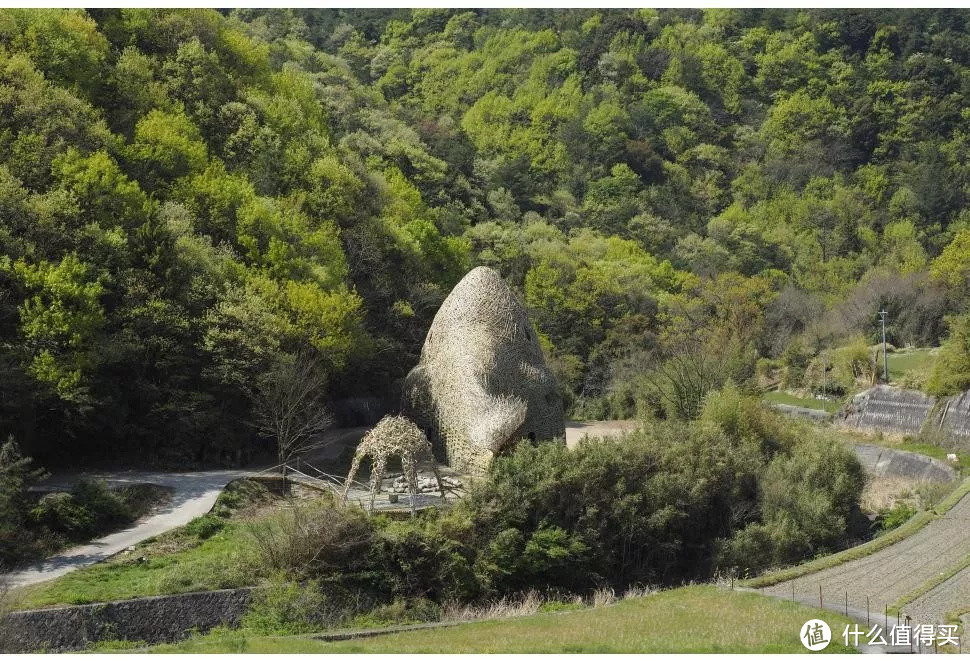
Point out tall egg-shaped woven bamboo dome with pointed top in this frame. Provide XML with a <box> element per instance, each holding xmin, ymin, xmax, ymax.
<box><xmin>403</xmin><ymin>267</ymin><xmax>565</xmax><ymax>473</ymax></box>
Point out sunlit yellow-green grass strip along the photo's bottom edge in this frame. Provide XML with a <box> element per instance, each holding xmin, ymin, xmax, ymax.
<box><xmin>144</xmin><ymin>585</ymin><xmax>854</xmax><ymax>653</ymax></box>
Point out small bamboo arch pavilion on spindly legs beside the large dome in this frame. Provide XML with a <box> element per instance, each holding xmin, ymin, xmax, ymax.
<box><xmin>341</xmin><ymin>416</ymin><xmax>445</xmax><ymax>517</ymax></box>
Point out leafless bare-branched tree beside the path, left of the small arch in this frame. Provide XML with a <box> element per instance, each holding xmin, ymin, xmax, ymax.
<box><xmin>255</xmin><ymin>353</ymin><xmax>333</xmax><ymax>482</ymax></box>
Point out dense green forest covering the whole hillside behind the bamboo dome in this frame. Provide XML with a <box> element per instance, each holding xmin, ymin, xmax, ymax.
<box><xmin>0</xmin><ymin>9</ymin><xmax>970</xmax><ymax>465</ymax></box>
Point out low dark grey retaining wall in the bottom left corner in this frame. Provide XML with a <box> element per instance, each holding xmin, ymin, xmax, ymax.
<box><xmin>0</xmin><ymin>588</ymin><xmax>252</xmax><ymax>653</ymax></box>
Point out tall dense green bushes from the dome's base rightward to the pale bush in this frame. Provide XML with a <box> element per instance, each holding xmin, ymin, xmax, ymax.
<box><xmin>465</xmin><ymin>387</ymin><xmax>865</xmax><ymax>592</ymax></box>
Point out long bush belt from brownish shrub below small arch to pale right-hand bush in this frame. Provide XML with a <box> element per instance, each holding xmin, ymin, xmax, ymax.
<box><xmin>246</xmin><ymin>384</ymin><xmax>868</xmax><ymax>604</ymax></box>
